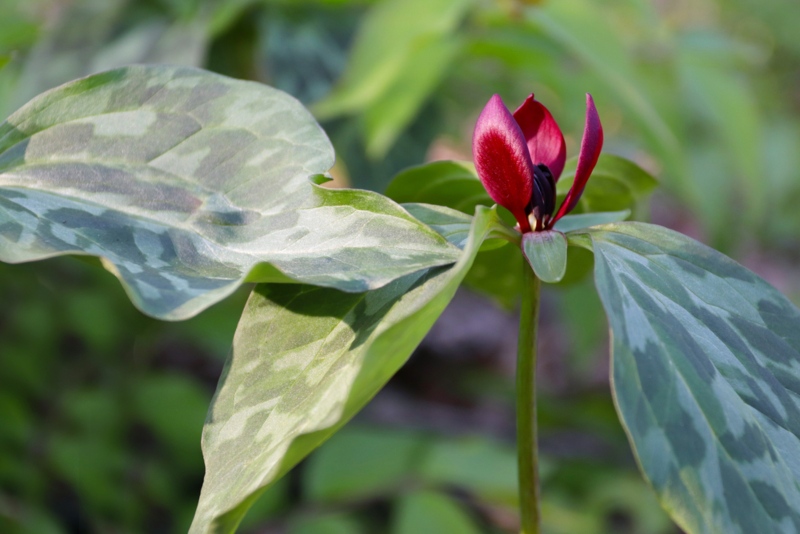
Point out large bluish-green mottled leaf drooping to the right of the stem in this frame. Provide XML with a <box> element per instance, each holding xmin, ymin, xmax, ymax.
<box><xmin>588</xmin><ymin>223</ymin><xmax>800</xmax><ymax>534</ymax></box>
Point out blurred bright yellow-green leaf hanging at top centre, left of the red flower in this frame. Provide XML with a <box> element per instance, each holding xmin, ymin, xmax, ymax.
<box><xmin>313</xmin><ymin>0</ymin><xmax>472</xmax><ymax>160</ymax></box>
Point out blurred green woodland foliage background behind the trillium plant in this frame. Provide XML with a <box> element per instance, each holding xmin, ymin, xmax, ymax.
<box><xmin>0</xmin><ymin>0</ymin><xmax>800</xmax><ymax>534</ymax></box>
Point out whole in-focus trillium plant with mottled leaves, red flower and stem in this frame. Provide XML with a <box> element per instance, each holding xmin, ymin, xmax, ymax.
<box><xmin>0</xmin><ymin>66</ymin><xmax>800</xmax><ymax>534</ymax></box>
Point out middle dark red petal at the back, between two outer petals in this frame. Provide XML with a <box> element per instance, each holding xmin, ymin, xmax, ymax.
<box><xmin>514</xmin><ymin>93</ymin><xmax>567</xmax><ymax>181</ymax></box>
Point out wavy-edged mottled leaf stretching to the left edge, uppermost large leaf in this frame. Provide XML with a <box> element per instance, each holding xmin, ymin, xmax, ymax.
<box><xmin>0</xmin><ymin>66</ymin><xmax>458</xmax><ymax>319</ymax></box>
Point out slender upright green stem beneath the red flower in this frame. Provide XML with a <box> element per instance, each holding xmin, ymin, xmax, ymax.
<box><xmin>516</xmin><ymin>259</ymin><xmax>541</xmax><ymax>534</ymax></box>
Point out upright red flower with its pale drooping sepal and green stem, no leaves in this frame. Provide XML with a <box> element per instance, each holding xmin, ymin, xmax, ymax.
<box><xmin>473</xmin><ymin>94</ymin><xmax>603</xmax><ymax>533</ymax></box>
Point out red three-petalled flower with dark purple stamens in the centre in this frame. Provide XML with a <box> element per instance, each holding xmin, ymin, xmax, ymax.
<box><xmin>472</xmin><ymin>94</ymin><xmax>603</xmax><ymax>234</ymax></box>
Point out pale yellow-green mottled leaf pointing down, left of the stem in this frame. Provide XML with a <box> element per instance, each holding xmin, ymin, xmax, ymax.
<box><xmin>191</xmin><ymin>208</ymin><xmax>497</xmax><ymax>534</ymax></box>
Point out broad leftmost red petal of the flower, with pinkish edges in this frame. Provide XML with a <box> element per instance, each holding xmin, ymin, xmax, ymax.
<box><xmin>472</xmin><ymin>95</ymin><xmax>533</xmax><ymax>233</ymax></box>
